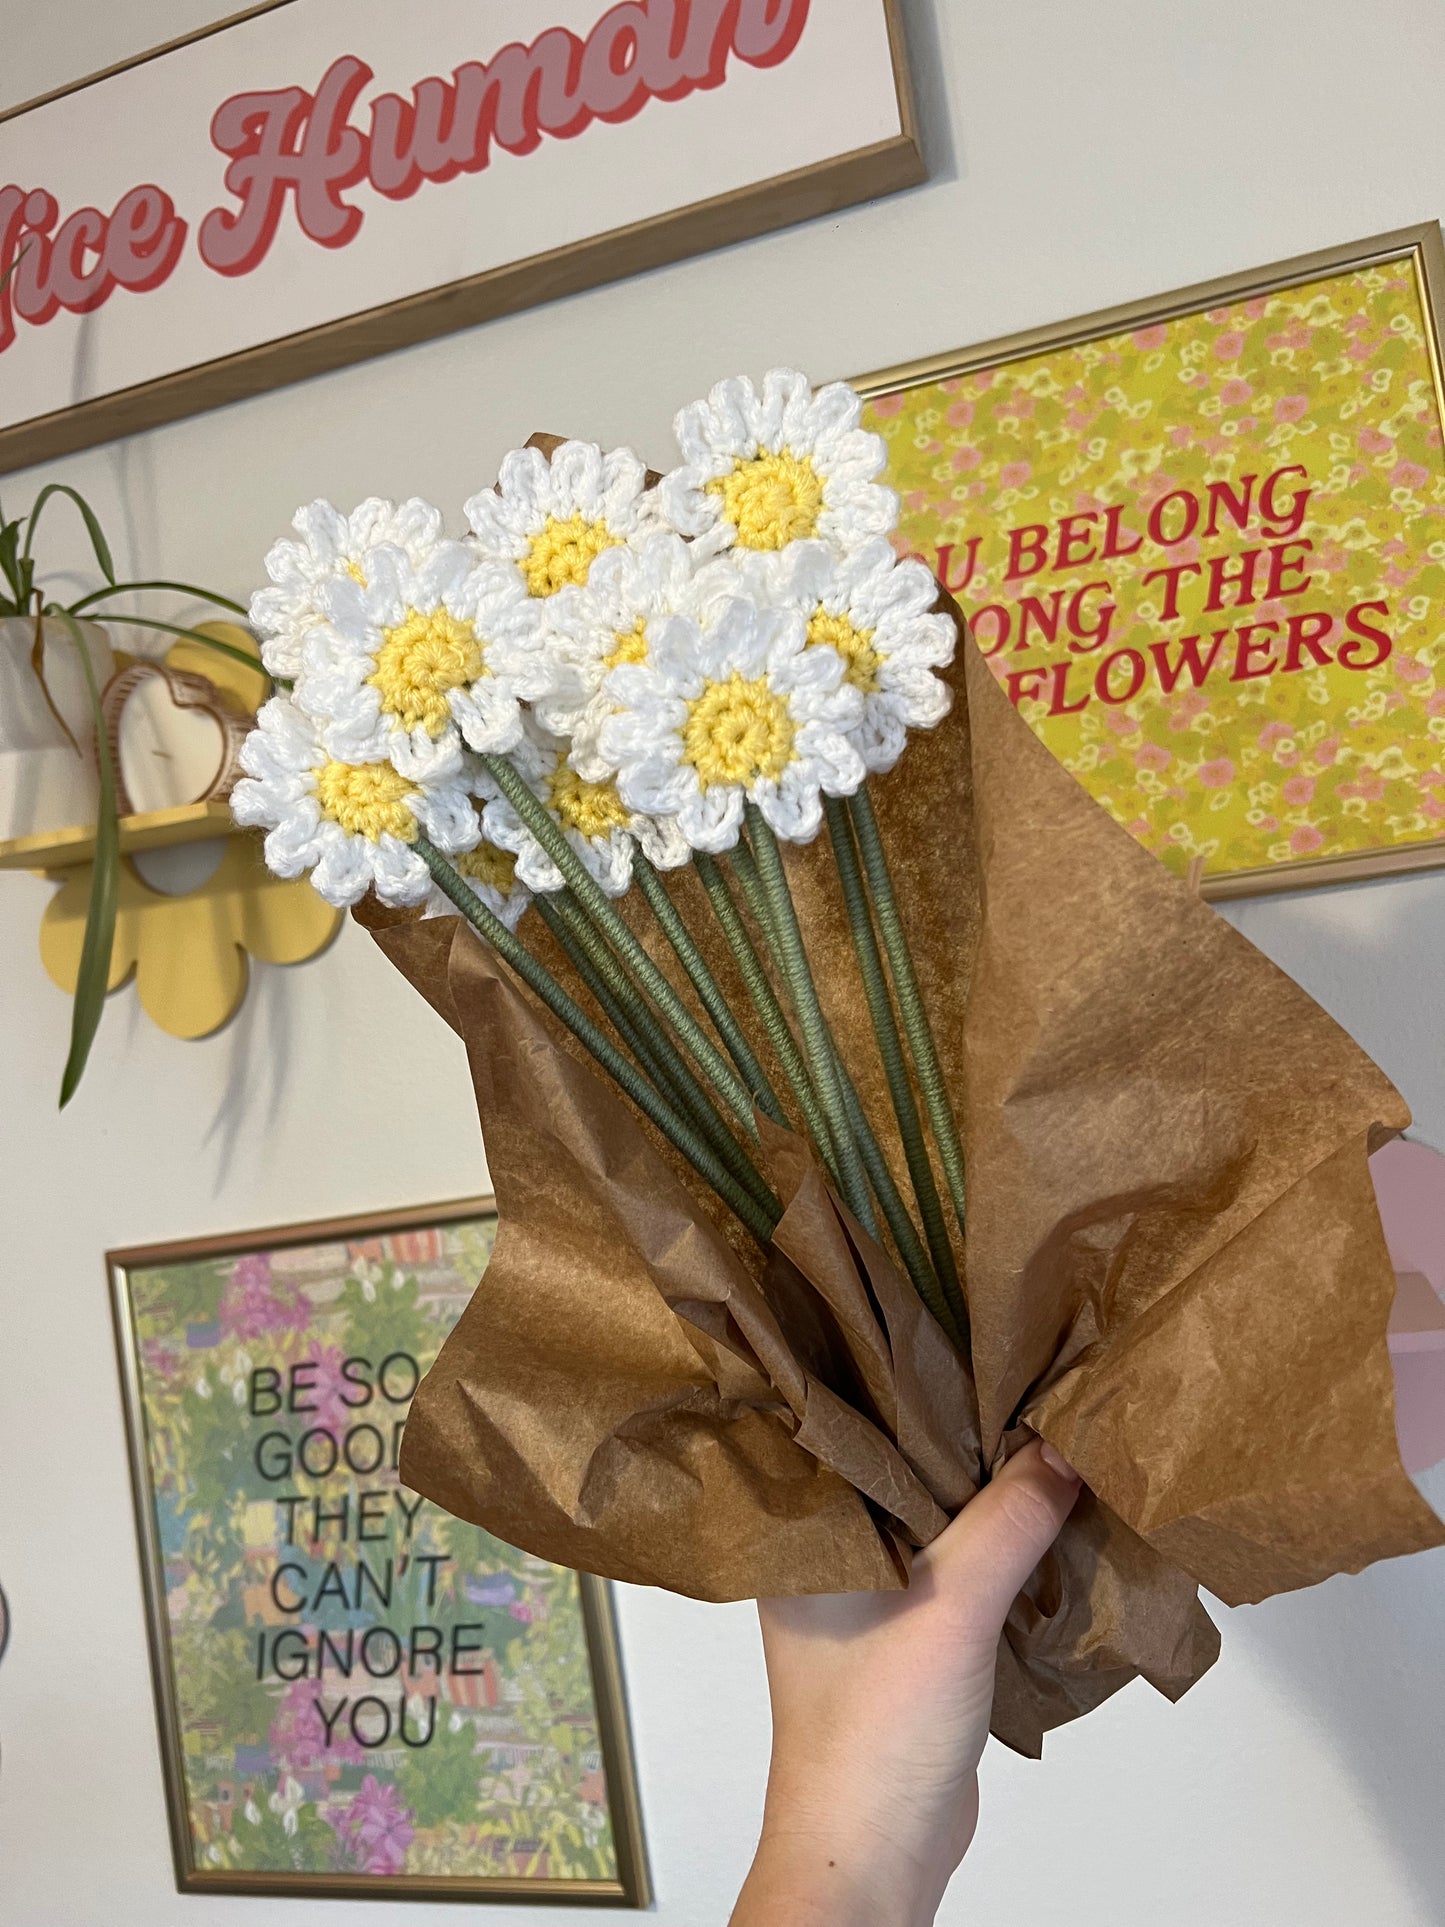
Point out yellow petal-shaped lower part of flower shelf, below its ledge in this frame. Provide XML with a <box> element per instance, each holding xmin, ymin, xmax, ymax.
<box><xmin>40</xmin><ymin>836</ymin><xmax>341</xmax><ymax>1037</ymax></box>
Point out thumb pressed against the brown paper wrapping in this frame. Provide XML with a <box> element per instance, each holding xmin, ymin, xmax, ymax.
<box><xmin>931</xmin><ymin>1439</ymin><xmax>1081</xmax><ymax>1626</ymax></box>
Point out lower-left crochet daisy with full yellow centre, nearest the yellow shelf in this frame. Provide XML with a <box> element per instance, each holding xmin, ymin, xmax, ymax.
<box><xmin>231</xmin><ymin>696</ymin><xmax>480</xmax><ymax>906</ymax></box>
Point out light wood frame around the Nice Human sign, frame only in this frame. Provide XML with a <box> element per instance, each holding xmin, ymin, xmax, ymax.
<box><xmin>0</xmin><ymin>0</ymin><xmax>927</xmax><ymax>474</ymax></box>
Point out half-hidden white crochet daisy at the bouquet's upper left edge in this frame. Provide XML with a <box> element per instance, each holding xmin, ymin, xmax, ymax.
<box><xmin>250</xmin><ymin>495</ymin><xmax>441</xmax><ymax>682</ymax></box>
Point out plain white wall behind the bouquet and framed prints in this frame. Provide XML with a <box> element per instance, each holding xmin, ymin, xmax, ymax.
<box><xmin>0</xmin><ymin>0</ymin><xmax>1445</xmax><ymax>1927</ymax></box>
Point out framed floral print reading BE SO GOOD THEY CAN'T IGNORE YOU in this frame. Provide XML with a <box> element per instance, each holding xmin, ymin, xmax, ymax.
<box><xmin>108</xmin><ymin>1199</ymin><xmax>649</xmax><ymax>1908</ymax></box>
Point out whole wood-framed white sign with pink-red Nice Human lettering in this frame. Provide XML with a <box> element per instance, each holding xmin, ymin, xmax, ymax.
<box><xmin>0</xmin><ymin>0</ymin><xmax>925</xmax><ymax>468</ymax></box>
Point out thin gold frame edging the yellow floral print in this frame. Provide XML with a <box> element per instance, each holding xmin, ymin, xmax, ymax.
<box><xmin>852</xmin><ymin>222</ymin><xmax>1445</xmax><ymax>900</ymax></box>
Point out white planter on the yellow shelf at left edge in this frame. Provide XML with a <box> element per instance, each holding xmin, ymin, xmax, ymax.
<box><xmin>0</xmin><ymin>617</ymin><xmax>116</xmax><ymax>842</ymax></box>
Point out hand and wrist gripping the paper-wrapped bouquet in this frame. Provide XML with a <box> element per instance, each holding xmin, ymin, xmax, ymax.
<box><xmin>732</xmin><ymin>1443</ymin><xmax>1079</xmax><ymax>1927</ymax></box>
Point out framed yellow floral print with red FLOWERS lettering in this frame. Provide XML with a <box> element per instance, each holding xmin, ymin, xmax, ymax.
<box><xmin>855</xmin><ymin>222</ymin><xmax>1445</xmax><ymax>896</ymax></box>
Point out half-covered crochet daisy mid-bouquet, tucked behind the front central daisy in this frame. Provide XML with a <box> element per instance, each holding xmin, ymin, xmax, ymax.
<box><xmin>536</xmin><ymin>534</ymin><xmax>738</xmax><ymax>782</ymax></box>
